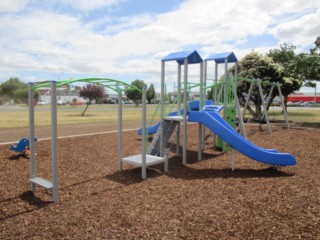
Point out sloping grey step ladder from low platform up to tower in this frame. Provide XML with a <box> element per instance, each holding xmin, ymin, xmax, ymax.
<box><xmin>147</xmin><ymin>119</ymin><xmax>180</xmax><ymax>156</ymax></box>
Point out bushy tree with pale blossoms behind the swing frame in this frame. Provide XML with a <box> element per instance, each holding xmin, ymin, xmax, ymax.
<box><xmin>237</xmin><ymin>52</ymin><xmax>283</xmax><ymax>120</ymax></box>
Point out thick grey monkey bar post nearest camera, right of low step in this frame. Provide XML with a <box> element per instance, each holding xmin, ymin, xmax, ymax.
<box><xmin>51</xmin><ymin>81</ymin><xmax>59</xmax><ymax>203</ymax></box>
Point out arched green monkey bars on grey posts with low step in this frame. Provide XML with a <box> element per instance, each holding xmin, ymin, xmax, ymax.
<box><xmin>29</xmin><ymin>78</ymin><xmax>141</xmax><ymax>203</ymax></box>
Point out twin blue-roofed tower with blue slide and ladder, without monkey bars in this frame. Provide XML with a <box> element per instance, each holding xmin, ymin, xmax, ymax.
<box><xmin>145</xmin><ymin>51</ymin><xmax>296</xmax><ymax>169</ymax></box>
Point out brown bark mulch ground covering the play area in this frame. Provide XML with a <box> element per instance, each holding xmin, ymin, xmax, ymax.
<box><xmin>0</xmin><ymin>124</ymin><xmax>320</xmax><ymax>239</ymax></box>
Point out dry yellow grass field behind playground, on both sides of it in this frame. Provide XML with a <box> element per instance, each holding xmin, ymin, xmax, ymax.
<box><xmin>0</xmin><ymin>104</ymin><xmax>320</xmax><ymax>129</ymax></box>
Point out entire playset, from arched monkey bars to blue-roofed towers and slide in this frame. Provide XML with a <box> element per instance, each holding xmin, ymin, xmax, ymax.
<box><xmin>25</xmin><ymin>51</ymin><xmax>296</xmax><ymax>203</ymax></box>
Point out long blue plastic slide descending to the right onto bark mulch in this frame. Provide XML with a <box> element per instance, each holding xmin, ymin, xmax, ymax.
<box><xmin>188</xmin><ymin>111</ymin><xmax>297</xmax><ymax>166</ymax></box>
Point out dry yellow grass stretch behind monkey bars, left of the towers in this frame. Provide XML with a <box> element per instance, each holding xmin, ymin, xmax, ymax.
<box><xmin>0</xmin><ymin>105</ymin><xmax>160</xmax><ymax>129</ymax></box>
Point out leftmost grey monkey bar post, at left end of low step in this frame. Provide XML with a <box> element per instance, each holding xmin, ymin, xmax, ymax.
<box><xmin>28</xmin><ymin>83</ymin><xmax>36</xmax><ymax>192</ymax></box>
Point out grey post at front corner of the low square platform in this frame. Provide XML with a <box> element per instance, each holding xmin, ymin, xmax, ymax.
<box><xmin>141</xmin><ymin>86</ymin><xmax>147</xmax><ymax>179</ymax></box>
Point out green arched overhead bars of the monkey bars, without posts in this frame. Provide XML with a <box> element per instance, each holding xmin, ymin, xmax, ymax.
<box><xmin>32</xmin><ymin>78</ymin><xmax>142</xmax><ymax>93</ymax></box>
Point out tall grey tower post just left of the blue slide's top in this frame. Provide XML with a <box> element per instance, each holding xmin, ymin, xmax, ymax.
<box><xmin>182</xmin><ymin>58</ymin><xmax>188</xmax><ymax>164</ymax></box>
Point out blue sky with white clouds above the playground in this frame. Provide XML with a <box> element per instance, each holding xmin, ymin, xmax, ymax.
<box><xmin>0</xmin><ymin>0</ymin><xmax>320</xmax><ymax>92</ymax></box>
